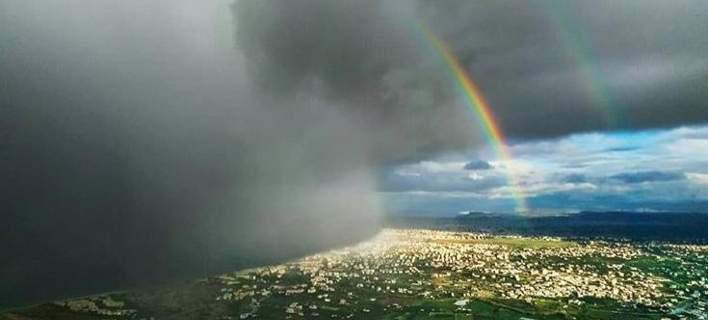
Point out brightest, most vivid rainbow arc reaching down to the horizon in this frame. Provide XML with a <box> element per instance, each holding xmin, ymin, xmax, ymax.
<box><xmin>422</xmin><ymin>26</ymin><xmax>528</xmax><ymax>212</ymax></box>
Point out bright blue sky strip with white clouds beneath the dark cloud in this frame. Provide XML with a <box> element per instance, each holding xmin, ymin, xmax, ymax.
<box><xmin>380</xmin><ymin>126</ymin><xmax>708</xmax><ymax>216</ymax></box>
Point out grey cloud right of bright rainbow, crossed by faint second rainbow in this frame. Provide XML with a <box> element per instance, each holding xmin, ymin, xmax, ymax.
<box><xmin>424</xmin><ymin>1</ymin><xmax>708</xmax><ymax>139</ymax></box>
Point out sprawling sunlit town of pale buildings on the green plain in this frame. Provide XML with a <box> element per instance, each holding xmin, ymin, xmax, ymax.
<box><xmin>212</xmin><ymin>229</ymin><xmax>708</xmax><ymax>318</ymax></box>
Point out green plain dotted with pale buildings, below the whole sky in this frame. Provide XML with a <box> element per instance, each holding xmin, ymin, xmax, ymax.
<box><xmin>5</xmin><ymin>229</ymin><xmax>708</xmax><ymax>319</ymax></box>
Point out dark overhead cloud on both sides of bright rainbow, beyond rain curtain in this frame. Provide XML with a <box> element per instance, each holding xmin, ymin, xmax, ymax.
<box><xmin>234</xmin><ymin>0</ymin><xmax>708</xmax><ymax>142</ymax></box>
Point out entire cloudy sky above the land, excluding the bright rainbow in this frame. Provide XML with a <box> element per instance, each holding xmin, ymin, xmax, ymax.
<box><xmin>0</xmin><ymin>0</ymin><xmax>708</xmax><ymax>304</ymax></box>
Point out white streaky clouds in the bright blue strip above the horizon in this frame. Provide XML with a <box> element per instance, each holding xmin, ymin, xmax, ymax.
<box><xmin>382</xmin><ymin>126</ymin><xmax>708</xmax><ymax>215</ymax></box>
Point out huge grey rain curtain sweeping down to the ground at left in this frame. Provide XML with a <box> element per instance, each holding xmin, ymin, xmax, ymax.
<box><xmin>0</xmin><ymin>0</ymin><xmax>392</xmax><ymax>308</ymax></box>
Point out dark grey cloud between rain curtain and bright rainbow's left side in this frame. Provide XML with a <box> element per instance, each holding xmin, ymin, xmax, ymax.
<box><xmin>233</xmin><ymin>0</ymin><xmax>479</xmax><ymax>162</ymax></box>
